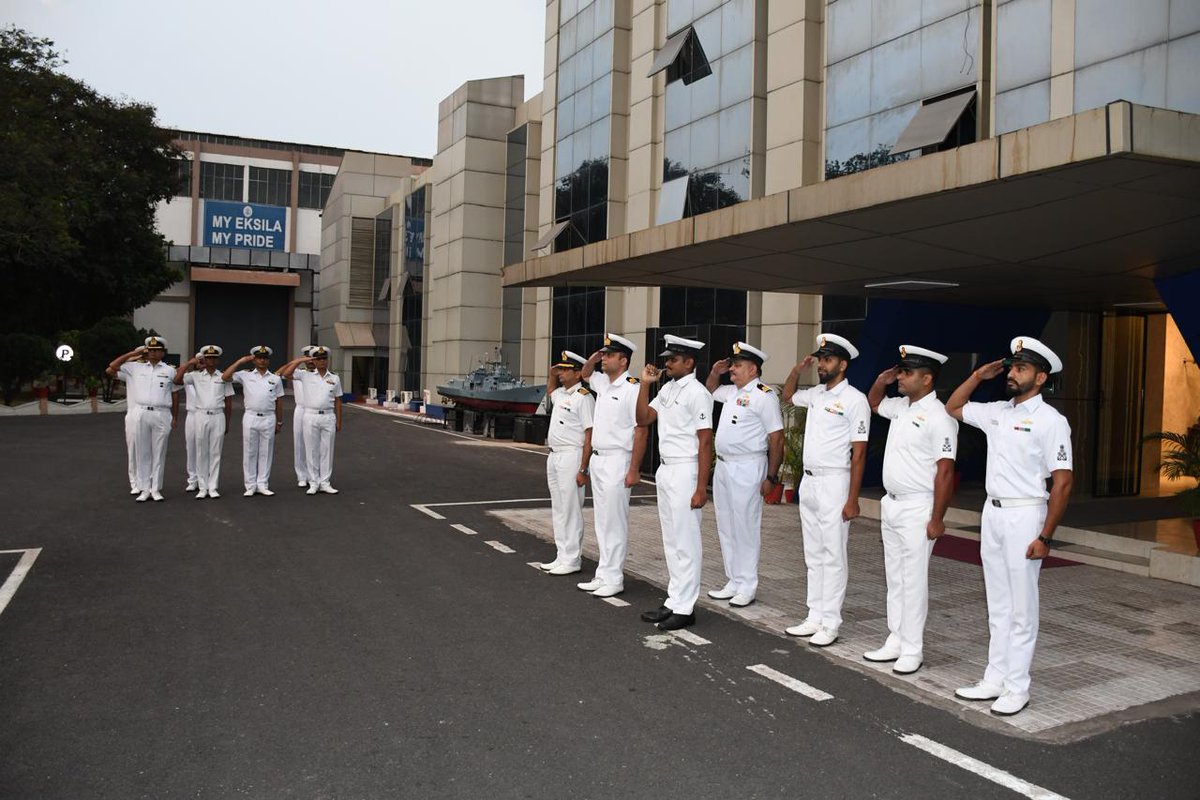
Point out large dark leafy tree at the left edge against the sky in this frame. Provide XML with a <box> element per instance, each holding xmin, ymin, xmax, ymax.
<box><xmin>0</xmin><ymin>28</ymin><xmax>181</xmax><ymax>336</ymax></box>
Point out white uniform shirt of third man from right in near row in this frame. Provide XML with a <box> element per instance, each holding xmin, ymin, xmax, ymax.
<box><xmin>792</xmin><ymin>379</ymin><xmax>871</xmax><ymax>469</ymax></box>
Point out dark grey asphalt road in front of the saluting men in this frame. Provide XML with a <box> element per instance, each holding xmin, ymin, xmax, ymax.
<box><xmin>0</xmin><ymin>410</ymin><xmax>1200</xmax><ymax>800</ymax></box>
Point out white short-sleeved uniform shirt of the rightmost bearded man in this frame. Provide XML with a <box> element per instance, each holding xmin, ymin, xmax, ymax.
<box><xmin>962</xmin><ymin>395</ymin><xmax>1072</xmax><ymax>499</ymax></box>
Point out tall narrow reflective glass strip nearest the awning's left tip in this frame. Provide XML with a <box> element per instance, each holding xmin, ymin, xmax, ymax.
<box><xmin>554</xmin><ymin>0</ymin><xmax>614</xmax><ymax>251</ymax></box>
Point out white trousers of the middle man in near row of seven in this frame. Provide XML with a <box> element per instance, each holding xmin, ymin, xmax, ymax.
<box><xmin>713</xmin><ymin>455</ymin><xmax>767</xmax><ymax>597</ymax></box>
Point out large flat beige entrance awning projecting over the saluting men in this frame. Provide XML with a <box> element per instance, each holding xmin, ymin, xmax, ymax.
<box><xmin>504</xmin><ymin>102</ymin><xmax>1200</xmax><ymax>309</ymax></box>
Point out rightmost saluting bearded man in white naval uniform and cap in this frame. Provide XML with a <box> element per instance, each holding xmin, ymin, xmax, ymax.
<box><xmin>946</xmin><ymin>336</ymin><xmax>1073</xmax><ymax>716</ymax></box>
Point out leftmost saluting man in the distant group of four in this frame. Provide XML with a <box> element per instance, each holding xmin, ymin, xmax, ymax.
<box><xmin>106</xmin><ymin>336</ymin><xmax>179</xmax><ymax>503</ymax></box>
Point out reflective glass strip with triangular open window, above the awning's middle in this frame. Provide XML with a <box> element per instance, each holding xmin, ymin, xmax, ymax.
<box><xmin>662</xmin><ymin>0</ymin><xmax>755</xmax><ymax>215</ymax></box>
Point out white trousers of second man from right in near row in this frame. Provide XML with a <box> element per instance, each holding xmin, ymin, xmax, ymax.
<box><xmin>880</xmin><ymin>494</ymin><xmax>934</xmax><ymax>661</ymax></box>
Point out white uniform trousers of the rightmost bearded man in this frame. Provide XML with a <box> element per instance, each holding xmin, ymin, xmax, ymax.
<box><xmin>979</xmin><ymin>503</ymin><xmax>1046</xmax><ymax>694</ymax></box>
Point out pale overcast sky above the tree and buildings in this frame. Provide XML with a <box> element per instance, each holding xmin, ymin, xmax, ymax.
<box><xmin>7</xmin><ymin>0</ymin><xmax>546</xmax><ymax>156</ymax></box>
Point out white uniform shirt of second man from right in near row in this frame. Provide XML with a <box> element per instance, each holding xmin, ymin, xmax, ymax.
<box><xmin>876</xmin><ymin>392</ymin><xmax>959</xmax><ymax>494</ymax></box>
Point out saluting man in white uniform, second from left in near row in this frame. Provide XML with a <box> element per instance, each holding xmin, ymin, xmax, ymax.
<box><xmin>576</xmin><ymin>333</ymin><xmax>648</xmax><ymax>597</ymax></box>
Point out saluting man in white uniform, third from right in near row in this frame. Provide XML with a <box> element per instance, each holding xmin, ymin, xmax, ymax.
<box><xmin>784</xmin><ymin>333</ymin><xmax>871</xmax><ymax>648</ymax></box>
